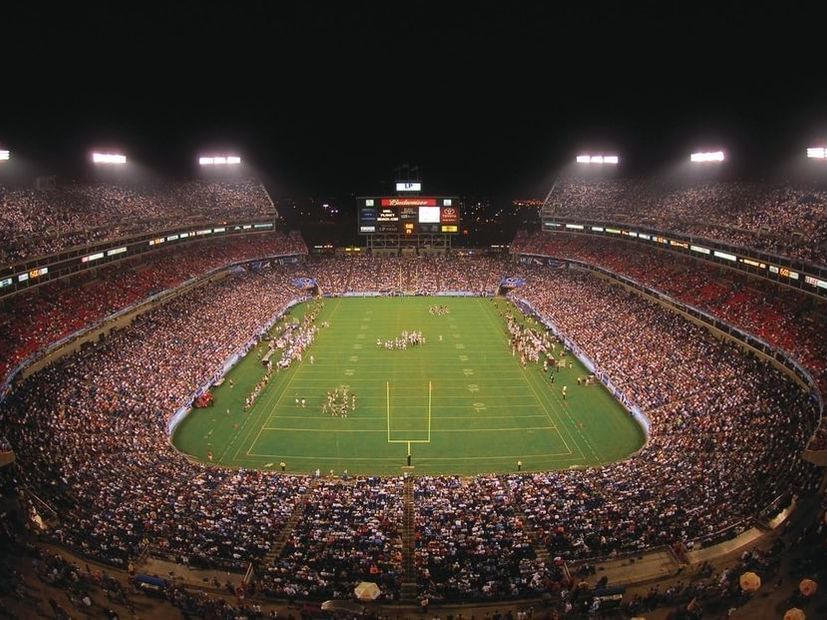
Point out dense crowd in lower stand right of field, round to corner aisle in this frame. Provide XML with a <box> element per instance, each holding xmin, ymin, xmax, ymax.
<box><xmin>509</xmin><ymin>269</ymin><xmax>818</xmax><ymax>558</ymax></box>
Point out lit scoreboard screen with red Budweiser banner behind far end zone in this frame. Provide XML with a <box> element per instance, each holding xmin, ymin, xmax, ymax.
<box><xmin>357</xmin><ymin>196</ymin><xmax>459</xmax><ymax>235</ymax></box>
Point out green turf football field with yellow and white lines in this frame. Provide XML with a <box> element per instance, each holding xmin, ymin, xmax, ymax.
<box><xmin>174</xmin><ymin>297</ymin><xmax>644</xmax><ymax>475</ymax></box>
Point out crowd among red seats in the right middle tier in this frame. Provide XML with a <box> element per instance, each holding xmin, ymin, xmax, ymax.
<box><xmin>512</xmin><ymin>233</ymin><xmax>827</xmax><ymax>449</ymax></box>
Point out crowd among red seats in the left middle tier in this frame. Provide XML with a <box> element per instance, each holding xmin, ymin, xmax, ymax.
<box><xmin>0</xmin><ymin>233</ymin><xmax>307</xmax><ymax>382</ymax></box>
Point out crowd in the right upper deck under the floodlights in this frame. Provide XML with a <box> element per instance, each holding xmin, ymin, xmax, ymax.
<box><xmin>549</xmin><ymin>177</ymin><xmax>827</xmax><ymax>265</ymax></box>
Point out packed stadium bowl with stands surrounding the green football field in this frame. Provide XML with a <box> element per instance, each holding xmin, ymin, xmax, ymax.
<box><xmin>2</xmin><ymin>159</ymin><xmax>827</xmax><ymax>616</ymax></box>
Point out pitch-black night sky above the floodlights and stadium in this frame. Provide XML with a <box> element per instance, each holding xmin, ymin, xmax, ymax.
<box><xmin>0</xmin><ymin>0</ymin><xmax>827</xmax><ymax>196</ymax></box>
